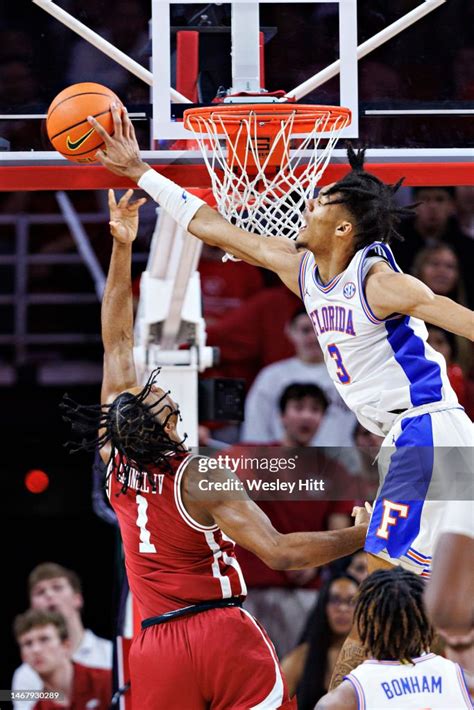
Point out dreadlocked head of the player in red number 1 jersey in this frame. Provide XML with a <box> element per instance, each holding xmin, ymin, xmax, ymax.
<box><xmin>60</xmin><ymin>368</ymin><xmax>186</xmax><ymax>493</ymax></box>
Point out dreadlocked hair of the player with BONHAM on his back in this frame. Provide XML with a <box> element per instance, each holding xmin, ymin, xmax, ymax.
<box><xmin>354</xmin><ymin>567</ymin><xmax>433</xmax><ymax>663</ymax></box>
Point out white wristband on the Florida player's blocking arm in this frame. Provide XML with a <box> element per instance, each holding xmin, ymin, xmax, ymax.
<box><xmin>138</xmin><ymin>169</ymin><xmax>206</xmax><ymax>229</ymax></box>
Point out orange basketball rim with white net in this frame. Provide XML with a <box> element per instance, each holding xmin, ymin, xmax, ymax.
<box><xmin>184</xmin><ymin>103</ymin><xmax>351</xmax><ymax>245</ymax></box>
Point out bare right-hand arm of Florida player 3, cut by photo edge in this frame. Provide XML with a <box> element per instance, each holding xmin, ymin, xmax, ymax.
<box><xmin>365</xmin><ymin>262</ymin><xmax>474</xmax><ymax>340</ymax></box>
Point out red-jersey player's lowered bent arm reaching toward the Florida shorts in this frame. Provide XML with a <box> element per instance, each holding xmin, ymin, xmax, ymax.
<box><xmin>184</xmin><ymin>459</ymin><xmax>369</xmax><ymax>570</ymax></box>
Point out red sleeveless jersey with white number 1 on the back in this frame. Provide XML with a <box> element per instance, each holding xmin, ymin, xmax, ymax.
<box><xmin>108</xmin><ymin>451</ymin><xmax>247</xmax><ymax>619</ymax></box>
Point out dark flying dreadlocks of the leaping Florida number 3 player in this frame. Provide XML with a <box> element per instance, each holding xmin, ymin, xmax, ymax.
<box><xmin>324</xmin><ymin>145</ymin><xmax>416</xmax><ymax>250</ymax></box>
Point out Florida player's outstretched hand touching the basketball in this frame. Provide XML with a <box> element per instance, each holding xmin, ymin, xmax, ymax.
<box><xmin>87</xmin><ymin>103</ymin><xmax>150</xmax><ymax>182</ymax></box>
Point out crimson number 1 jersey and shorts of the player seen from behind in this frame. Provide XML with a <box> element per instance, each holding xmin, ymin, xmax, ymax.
<box><xmin>108</xmin><ymin>452</ymin><xmax>292</xmax><ymax>710</ymax></box>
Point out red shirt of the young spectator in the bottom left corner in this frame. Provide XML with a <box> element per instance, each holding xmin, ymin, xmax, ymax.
<box><xmin>33</xmin><ymin>663</ymin><xmax>112</xmax><ymax>710</ymax></box>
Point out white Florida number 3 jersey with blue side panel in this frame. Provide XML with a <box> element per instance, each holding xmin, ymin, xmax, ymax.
<box><xmin>299</xmin><ymin>242</ymin><xmax>458</xmax><ymax>436</ymax></box>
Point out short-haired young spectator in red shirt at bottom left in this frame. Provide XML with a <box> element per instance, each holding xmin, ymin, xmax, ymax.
<box><xmin>14</xmin><ymin>609</ymin><xmax>112</xmax><ymax>710</ymax></box>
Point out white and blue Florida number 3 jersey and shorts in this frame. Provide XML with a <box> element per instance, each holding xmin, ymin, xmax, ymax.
<box><xmin>299</xmin><ymin>242</ymin><xmax>473</xmax><ymax>576</ymax></box>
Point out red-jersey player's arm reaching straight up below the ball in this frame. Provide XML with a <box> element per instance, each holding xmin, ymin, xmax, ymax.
<box><xmin>101</xmin><ymin>190</ymin><xmax>146</xmax><ymax>403</ymax></box>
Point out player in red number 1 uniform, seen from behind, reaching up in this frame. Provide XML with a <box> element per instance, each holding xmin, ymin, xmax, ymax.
<box><xmin>61</xmin><ymin>190</ymin><xmax>368</xmax><ymax>710</ymax></box>
